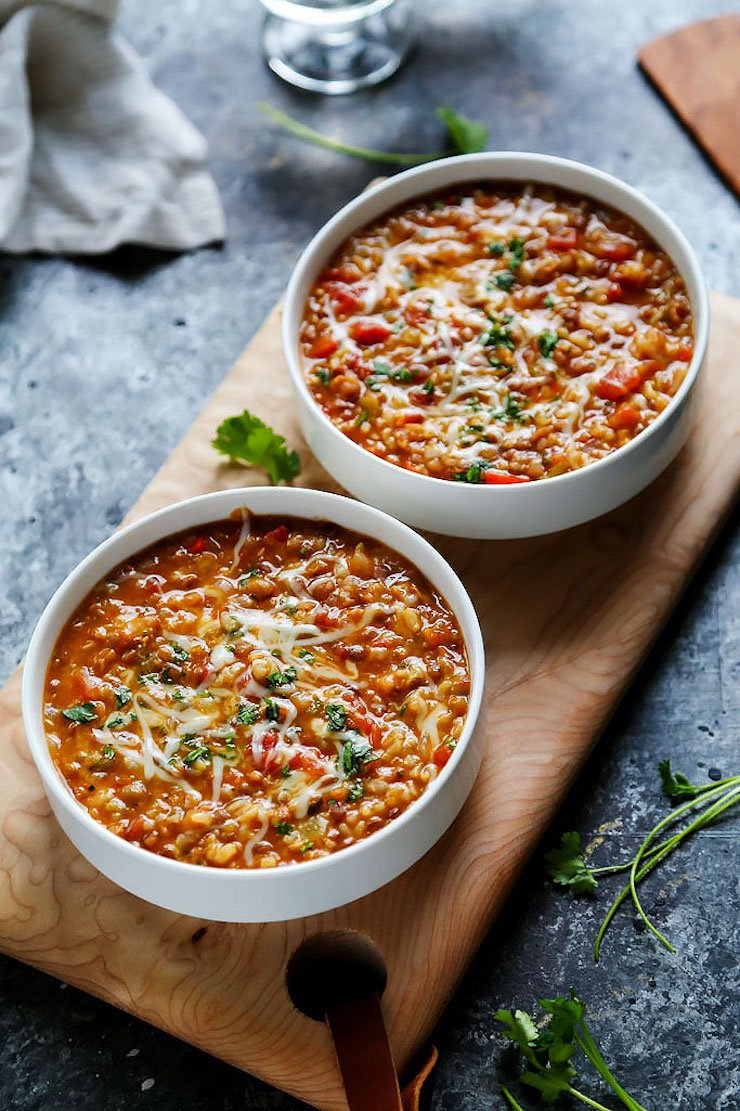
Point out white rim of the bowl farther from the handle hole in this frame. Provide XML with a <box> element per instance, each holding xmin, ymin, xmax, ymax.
<box><xmin>281</xmin><ymin>151</ymin><xmax>710</xmax><ymax>498</ymax></box>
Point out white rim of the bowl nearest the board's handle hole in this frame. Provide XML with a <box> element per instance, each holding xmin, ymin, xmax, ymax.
<box><xmin>21</xmin><ymin>487</ymin><xmax>486</xmax><ymax>888</ymax></box>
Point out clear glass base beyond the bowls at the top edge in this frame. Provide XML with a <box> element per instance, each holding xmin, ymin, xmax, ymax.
<box><xmin>260</xmin><ymin>0</ymin><xmax>416</xmax><ymax>94</ymax></box>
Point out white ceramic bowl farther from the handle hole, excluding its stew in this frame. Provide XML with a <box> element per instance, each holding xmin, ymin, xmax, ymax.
<box><xmin>282</xmin><ymin>152</ymin><xmax>709</xmax><ymax>539</ymax></box>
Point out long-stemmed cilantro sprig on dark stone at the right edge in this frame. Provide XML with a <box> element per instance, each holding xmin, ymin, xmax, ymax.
<box><xmin>544</xmin><ymin>760</ymin><xmax>740</xmax><ymax>961</ymax></box>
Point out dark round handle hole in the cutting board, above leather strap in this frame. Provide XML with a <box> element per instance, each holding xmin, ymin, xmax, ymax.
<box><xmin>286</xmin><ymin>930</ymin><xmax>388</xmax><ymax>1022</ymax></box>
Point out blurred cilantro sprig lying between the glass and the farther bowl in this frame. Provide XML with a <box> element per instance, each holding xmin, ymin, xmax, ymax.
<box><xmin>257</xmin><ymin>101</ymin><xmax>488</xmax><ymax>166</ymax></box>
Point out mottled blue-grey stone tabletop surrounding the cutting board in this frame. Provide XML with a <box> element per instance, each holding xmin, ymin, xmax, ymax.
<box><xmin>0</xmin><ymin>0</ymin><xmax>740</xmax><ymax>1111</ymax></box>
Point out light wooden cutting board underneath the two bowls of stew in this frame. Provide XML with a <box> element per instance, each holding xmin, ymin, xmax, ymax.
<box><xmin>0</xmin><ymin>296</ymin><xmax>740</xmax><ymax>1111</ymax></box>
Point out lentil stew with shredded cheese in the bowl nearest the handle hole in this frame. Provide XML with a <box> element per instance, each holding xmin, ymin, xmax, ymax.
<box><xmin>44</xmin><ymin>512</ymin><xmax>470</xmax><ymax>869</ymax></box>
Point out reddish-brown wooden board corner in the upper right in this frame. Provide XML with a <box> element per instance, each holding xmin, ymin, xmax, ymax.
<box><xmin>638</xmin><ymin>12</ymin><xmax>740</xmax><ymax>196</ymax></box>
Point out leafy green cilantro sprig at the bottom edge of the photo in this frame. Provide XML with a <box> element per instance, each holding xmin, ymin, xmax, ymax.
<box><xmin>494</xmin><ymin>992</ymin><xmax>646</xmax><ymax>1111</ymax></box>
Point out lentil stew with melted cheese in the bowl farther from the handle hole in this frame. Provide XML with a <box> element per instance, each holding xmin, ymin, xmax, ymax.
<box><xmin>300</xmin><ymin>184</ymin><xmax>692</xmax><ymax>484</ymax></box>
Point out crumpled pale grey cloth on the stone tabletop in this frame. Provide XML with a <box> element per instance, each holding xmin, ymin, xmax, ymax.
<box><xmin>0</xmin><ymin>0</ymin><xmax>224</xmax><ymax>254</ymax></box>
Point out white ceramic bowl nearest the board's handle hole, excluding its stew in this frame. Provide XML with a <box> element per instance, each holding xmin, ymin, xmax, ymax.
<box><xmin>22</xmin><ymin>488</ymin><xmax>484</xmax><ymax>922</ymax></box>
